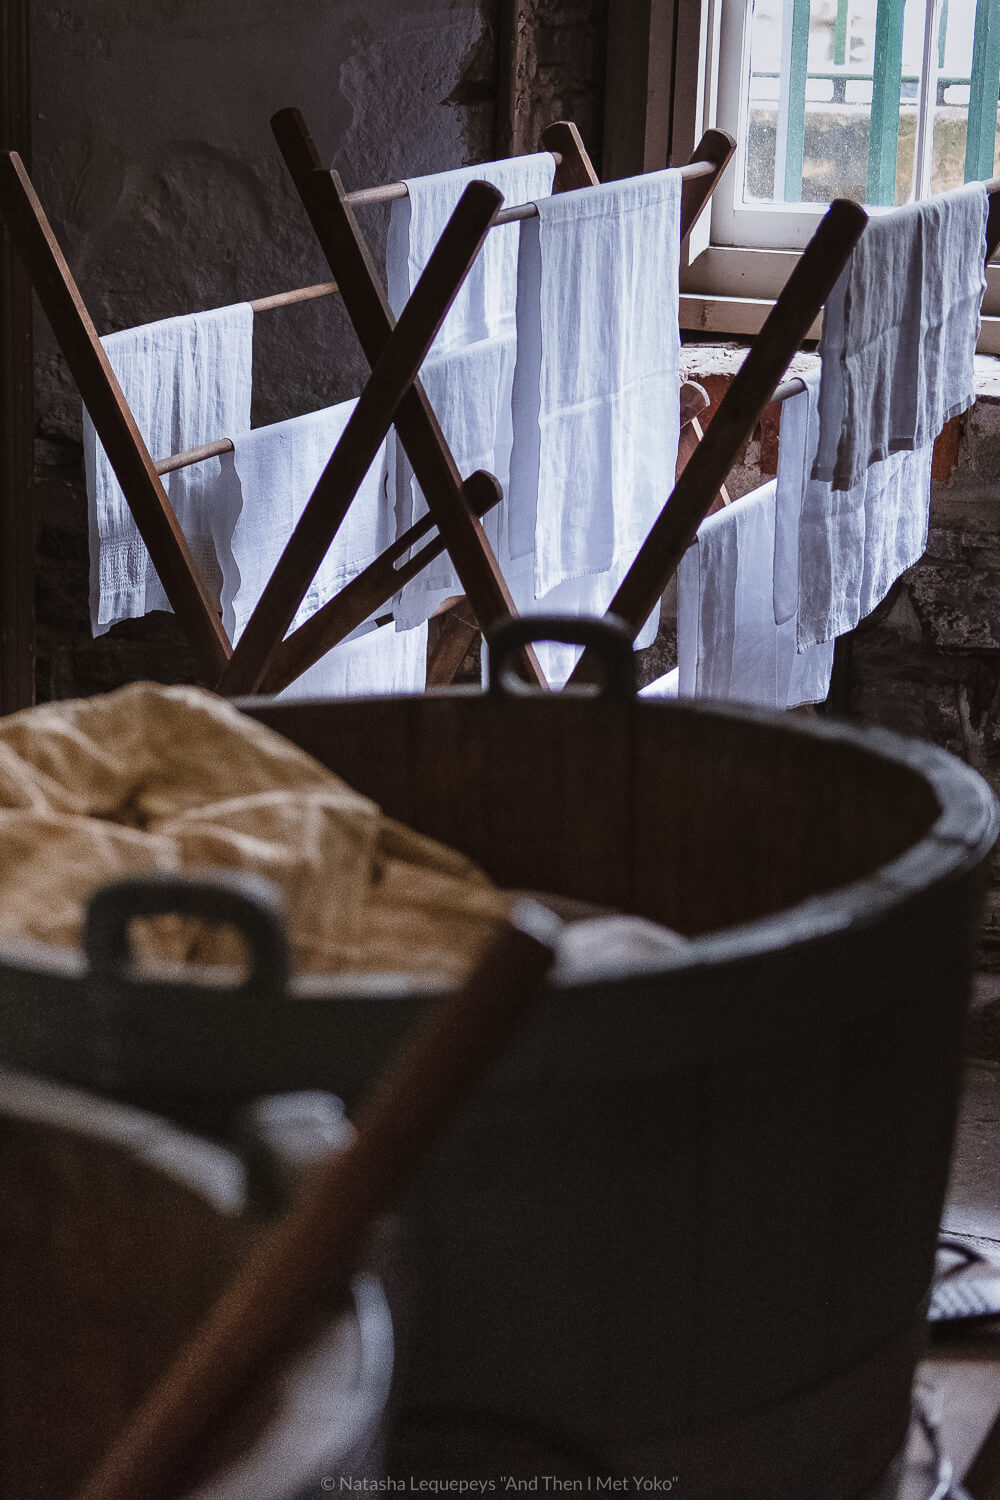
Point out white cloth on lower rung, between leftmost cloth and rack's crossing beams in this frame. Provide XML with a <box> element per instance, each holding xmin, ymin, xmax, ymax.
<box><xmin>223</xmin><ymin>401</ymin><xmax>427</xmax><ymax>698</ymax></box>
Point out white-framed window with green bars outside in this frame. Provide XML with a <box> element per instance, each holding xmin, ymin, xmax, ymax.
<box><xmin>685</xmin><ymin>0</ymin><xmax>1000</xmax><ymax>350</ymax></box>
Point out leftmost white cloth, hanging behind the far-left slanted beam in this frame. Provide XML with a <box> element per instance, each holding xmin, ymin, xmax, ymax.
<box><xmin>84</xmin><ymin>303</ymin><xmax>253</xmax><ymax>636</ymax></box>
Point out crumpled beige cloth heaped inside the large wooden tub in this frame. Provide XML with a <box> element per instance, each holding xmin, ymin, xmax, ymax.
<box><xmin>0</xmin><ymin>683</ymin><xmax>510</xmax><ymax>978</ymax></box>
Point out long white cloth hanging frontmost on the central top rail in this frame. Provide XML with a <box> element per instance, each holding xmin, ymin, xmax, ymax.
<box><xmin>508</xmin><ymin>171</ymin><xmax>681</xmax><ymax>686</ymax></box>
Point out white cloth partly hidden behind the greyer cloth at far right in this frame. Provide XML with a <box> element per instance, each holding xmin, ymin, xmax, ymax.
<box><xmin>774</xmin><ymin>370</ymin><xmax>934</xmax><ymax>651</ymax></box>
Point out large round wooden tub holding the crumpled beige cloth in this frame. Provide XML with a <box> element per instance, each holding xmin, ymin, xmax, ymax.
<box><xmin>0</xmin><ymin>618</ymin><xmax>997</xmax><ymax>1500</ymax></box>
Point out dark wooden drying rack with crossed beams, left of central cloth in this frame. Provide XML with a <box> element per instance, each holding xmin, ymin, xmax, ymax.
<box><xmin>0</xmin><ymin>120</ymin><xmax>733</xmax><ymax>695</ymax></box>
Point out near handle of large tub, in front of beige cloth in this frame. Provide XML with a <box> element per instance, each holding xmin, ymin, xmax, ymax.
<box><xmin>82</xmin><ymin>870</ymin><xmax>289</xmax><ymax>996</ymax></box>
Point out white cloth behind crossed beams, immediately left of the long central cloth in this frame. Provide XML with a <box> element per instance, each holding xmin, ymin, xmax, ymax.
<box><xmin>385</xmin><ymin>152</ymin><xmax>555</xmax><ymax>629</ymax></box>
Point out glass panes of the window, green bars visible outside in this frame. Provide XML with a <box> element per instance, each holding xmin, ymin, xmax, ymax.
<box><xmin>742</xmin><ymin>0</ymin><xmax>1000</xmax><ymax>206</ymax></box>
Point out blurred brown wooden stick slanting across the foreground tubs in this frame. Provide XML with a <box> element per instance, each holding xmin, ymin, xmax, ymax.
<box><xmin>78</xmin><ymin>902</ymin><xmax>558</xmax><ymax>1500</ymax></box>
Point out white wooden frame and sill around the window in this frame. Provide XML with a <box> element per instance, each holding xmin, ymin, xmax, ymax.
<box><xmin>673</xmin><ymin>0</ymin><xmax>1000</xmax><ymax>354</ymax></box>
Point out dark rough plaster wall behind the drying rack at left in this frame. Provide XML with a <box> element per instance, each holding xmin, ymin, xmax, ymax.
<box><xmin>31</xmin><ymin>0</ymin><xmax>496</xmax><ymax>698</ymax></box>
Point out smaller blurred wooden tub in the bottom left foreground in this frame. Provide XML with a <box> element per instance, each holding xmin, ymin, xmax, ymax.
<box><xmin>0</xmin><ymin>1070</ymin><xmax>391</xmax><ymax>1500</ymax></box>
